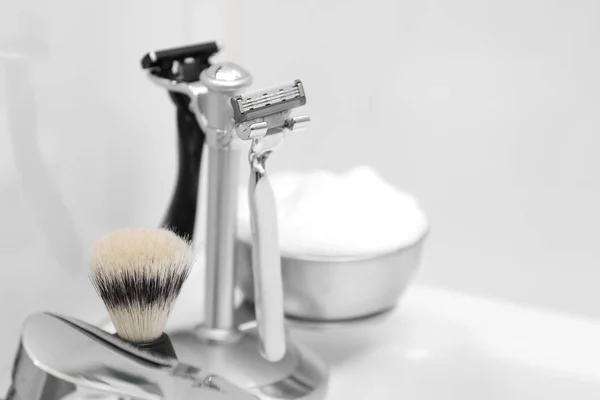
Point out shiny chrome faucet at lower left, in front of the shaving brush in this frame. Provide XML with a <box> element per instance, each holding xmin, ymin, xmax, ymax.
<box><xmin>7</xmin><ymin>313</ymin><xmax>255</xmax><ymax>400</ymax></box>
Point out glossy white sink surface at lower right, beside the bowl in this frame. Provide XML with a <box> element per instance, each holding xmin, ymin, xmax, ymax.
<box><xmin>294</xmin><ymin>286</ymin><xmax>600</xmax><ymax>400</ymax></box>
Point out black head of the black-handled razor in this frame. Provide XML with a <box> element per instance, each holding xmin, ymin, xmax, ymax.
<box><xmin>141</xmin><ymin>42</ymin><xmax>219</xmax><ymax>82</ymax></box>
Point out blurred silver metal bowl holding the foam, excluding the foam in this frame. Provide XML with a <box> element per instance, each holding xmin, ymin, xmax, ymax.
<box><xmin>236</xmin><ymin>235</ymin><xmax>426</xmax><ymax>322</ymax></box>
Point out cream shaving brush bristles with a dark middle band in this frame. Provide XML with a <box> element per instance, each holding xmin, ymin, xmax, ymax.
<box><xmin>90</xmin><ymin>228</ymin><xmax>194</xmax><ymax>343</ymax></box>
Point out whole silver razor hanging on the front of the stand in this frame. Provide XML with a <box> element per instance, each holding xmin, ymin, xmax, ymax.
<box><xmin>231</xmin><ymin>80</ymin><xmax>310</xmax><ymax>362</ymax></box>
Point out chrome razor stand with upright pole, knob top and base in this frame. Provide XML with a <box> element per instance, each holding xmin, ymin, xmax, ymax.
<box><xmin>150</xmin><ymin>63</ymin><xmax>328</xmax><ymax>400</ymax></box>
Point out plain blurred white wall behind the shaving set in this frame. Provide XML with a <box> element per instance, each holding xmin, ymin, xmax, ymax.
<box><xmin>0</xmin><ymin>0</ymin><xmax>600</xmax><ymax>376</ymax></box>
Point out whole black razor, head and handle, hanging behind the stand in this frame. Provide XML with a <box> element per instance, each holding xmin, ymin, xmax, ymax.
<box><xmin>141</xmin><ymin>42</ymin><xmax>219</xmax><ymax>240</ymax></box>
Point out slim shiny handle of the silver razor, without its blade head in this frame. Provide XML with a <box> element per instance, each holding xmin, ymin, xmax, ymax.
<box><xmin>248</xmin><ymin>134</ymin><xmax>286</xmax><ymax>361</ymax></box>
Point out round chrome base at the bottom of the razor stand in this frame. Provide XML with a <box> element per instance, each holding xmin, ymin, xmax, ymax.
<box><xmin>169</xmin><ymin>327</ymin><xmax>328</xmax><ymax>400</ymax></box>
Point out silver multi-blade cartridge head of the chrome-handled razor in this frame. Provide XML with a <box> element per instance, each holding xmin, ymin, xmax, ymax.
<box><xmin>231</xmin><ymin>79</ymin><xmax>306</xmax><ymax>124</ymax></box>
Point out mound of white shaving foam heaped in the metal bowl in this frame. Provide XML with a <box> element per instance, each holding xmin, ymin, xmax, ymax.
<box><xmin>238</xmin><ymin>167</ymin><xmax>428</xmax><ymax>258</ymax></box>
